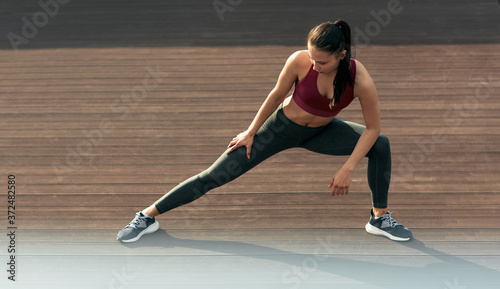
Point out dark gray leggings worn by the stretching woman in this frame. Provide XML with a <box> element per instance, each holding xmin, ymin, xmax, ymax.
<box><xmin>155</xmin><ymin>108</ymin><xmax>391</xmax><ymax>214</ymax></box>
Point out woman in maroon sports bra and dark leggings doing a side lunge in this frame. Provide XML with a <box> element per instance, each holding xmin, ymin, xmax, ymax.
<box><xmin>117</xmin><ymin>20</ymin><xmax>412</xmax><ymax>242</ymax></box>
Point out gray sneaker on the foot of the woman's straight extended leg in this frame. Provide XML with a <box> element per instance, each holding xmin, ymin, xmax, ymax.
<box><xmin>116</xmin><ymin>212</ymin><xmax>160</xmax><ymax>243</ymax></box>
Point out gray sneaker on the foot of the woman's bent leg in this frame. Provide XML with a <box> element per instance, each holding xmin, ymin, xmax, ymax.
<box><xmin>365</xmin><ymin>210</ymin><xmax>413</xmax><ymax>241</ymax></box>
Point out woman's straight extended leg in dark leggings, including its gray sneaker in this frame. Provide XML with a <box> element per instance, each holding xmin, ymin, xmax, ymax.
<box><xmin>117</xmin><ymin>109</ymin><xmax>300</xmax><ymax>242</ymax></box>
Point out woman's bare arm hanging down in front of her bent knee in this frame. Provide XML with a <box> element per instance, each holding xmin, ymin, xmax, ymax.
<box><xmin>329</xmin><ymin>61</ymin><xmax>380</xmax><ymax>196</ymax></box>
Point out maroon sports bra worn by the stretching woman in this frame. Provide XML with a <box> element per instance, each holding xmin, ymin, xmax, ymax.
<box><xmin>292</xmin><ymin>58</ymin><xmax>356</xmax><ymax>117</ymax></box>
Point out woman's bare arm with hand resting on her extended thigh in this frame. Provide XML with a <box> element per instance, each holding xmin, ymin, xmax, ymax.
<box><xmin>227</xmin><ymin>51</ymin><xmax>303</xmax><ymax>158</ymax></box>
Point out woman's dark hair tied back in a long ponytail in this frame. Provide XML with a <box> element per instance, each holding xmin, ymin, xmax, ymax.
<box><xmin>307</xmin><ymin>19</ymin><xmax>354</xmax><ymax>106</ymax></box>
